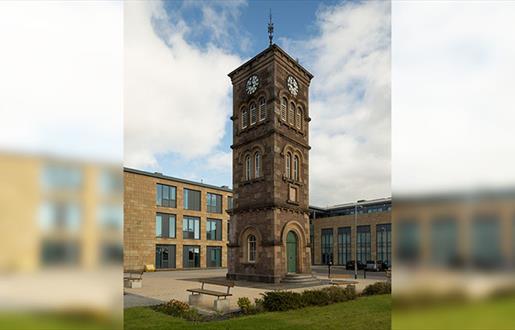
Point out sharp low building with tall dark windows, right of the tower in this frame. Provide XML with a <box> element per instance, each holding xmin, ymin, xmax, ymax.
<box><xmin>310</xmin><ymin>198</ymin><xmax>392</xmax><ymax>266</ymax></box>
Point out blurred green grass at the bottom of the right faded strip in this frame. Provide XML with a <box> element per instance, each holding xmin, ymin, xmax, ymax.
<box><xmin>392</xmin><ymin>297</ymin><xmax>515</xmax><ymax>330</ymax></box>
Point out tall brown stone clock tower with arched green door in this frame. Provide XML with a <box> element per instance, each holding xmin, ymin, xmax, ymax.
<box><xmin>227</xmin><ymin>38</ymin><xmax>313</xmax><ymax>283</ymax></box>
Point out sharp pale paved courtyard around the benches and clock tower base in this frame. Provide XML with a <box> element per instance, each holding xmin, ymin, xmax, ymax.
<box><xmin>124</xmin><ymin>269</ymin><xmax>379</xmax><ymax>310</ymax></box>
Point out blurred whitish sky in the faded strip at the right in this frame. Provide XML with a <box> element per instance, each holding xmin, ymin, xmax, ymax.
<box><xmin>392</xmin><ymin>2</ymin><xmax>515</xmax><ymax>193</ymax></box>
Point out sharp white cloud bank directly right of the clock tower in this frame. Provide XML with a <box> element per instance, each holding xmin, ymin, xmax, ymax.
<box><xmin>286</xmin><ymin>2</ymin><xmax>391</xmax><ymax>206</ymax></box>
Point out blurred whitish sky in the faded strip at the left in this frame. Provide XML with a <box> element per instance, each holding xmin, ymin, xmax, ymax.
<box><xmin>0</xmin><ymin>1</ymin><xmax>123</xmax><ymax>162</ymax></box>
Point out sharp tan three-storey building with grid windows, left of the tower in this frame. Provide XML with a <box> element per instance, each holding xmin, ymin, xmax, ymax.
<box><xmin>123</xmin><ymin>168</ymin><xmax>232</xmax><ymax>269</ymax></box>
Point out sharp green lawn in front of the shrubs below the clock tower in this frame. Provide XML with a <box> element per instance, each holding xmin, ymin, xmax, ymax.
<box><xmin>124</xmin><ymin>295</ymin><xmax>391</xmax><ymax>330</ymax></box>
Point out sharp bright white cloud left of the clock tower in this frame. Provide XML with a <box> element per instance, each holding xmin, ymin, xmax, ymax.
<box><xmin>124</xmin><ymin>2</ymin><xmax>241</xmax><ymax>167</ymax></box>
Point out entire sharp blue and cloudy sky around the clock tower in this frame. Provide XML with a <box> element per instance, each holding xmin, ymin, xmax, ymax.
<box><xmin>124</xmin><ymin>1</ymin><xmax>391</xmax><ymax>206</ymax></box>
